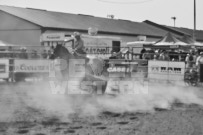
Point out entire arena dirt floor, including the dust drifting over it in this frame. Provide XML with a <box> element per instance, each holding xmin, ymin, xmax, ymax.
<box><xmin>0</xmin><ymin>83</ymin><xmax>203</xmax><ymax>135</ymax></box>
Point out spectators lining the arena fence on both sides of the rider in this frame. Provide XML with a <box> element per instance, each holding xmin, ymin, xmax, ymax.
<box><xmin>0</xmin><ymin>46</ymin><xmax>203</xmax><ymax>68</ymax></box>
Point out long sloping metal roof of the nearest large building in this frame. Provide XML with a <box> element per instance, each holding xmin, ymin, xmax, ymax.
<box><xmin>0</xmin><ymin>5</ymin><xmax>167</xmax><ymax>37</ymax></box>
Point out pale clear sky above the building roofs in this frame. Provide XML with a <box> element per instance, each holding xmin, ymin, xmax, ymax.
<box><xmin>0</xmin><ymin>0</ymin><xmax>203</xmax><ymax>30</ymax></box>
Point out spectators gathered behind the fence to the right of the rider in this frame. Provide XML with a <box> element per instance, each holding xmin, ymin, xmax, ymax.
<box><xmin>109</xmin><ymin>48</ymin><xmax>203</xmax><ymax>69</ymax></box>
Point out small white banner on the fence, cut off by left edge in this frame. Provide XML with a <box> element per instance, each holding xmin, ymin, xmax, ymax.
<box><xmin>0</xmin><ymin>59</ymin><xmax>9</xmax><ymax>78</ymax></box>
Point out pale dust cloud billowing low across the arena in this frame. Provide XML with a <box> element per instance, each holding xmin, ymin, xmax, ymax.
<box><xmin>0</xmin><ymin>82</ymin><xmax>203</xmax><ymax>121</ymax></box>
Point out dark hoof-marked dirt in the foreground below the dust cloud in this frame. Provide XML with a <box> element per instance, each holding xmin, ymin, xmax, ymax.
<box><xmin>0</xmin><ymin>81</ymin><xmax>203</xmax><ymax>135</ymax></box>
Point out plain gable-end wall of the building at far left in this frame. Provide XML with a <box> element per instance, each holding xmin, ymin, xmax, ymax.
<box><xmin>0</xmin><ymin>11</ymin><xmax>41</xmax><ymax>46</ymax></box>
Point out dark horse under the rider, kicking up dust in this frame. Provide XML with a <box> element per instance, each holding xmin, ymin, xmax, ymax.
<box><xmin>54</xmin><ymin>45</ymin><xmax>107</xmax><ymax>94</ymax></box>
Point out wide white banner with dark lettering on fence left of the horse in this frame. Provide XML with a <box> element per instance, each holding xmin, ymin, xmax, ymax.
<box><xmin>14</xmin><ymin>59</ymin><xmax>50</xmax><ymax>73</ymax></box>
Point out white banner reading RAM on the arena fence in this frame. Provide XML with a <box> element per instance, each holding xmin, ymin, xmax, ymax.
<box><xmin>148</xmin><ymin>60</ymin><xmax>185</xmax><ymax>81</ymax></box>
